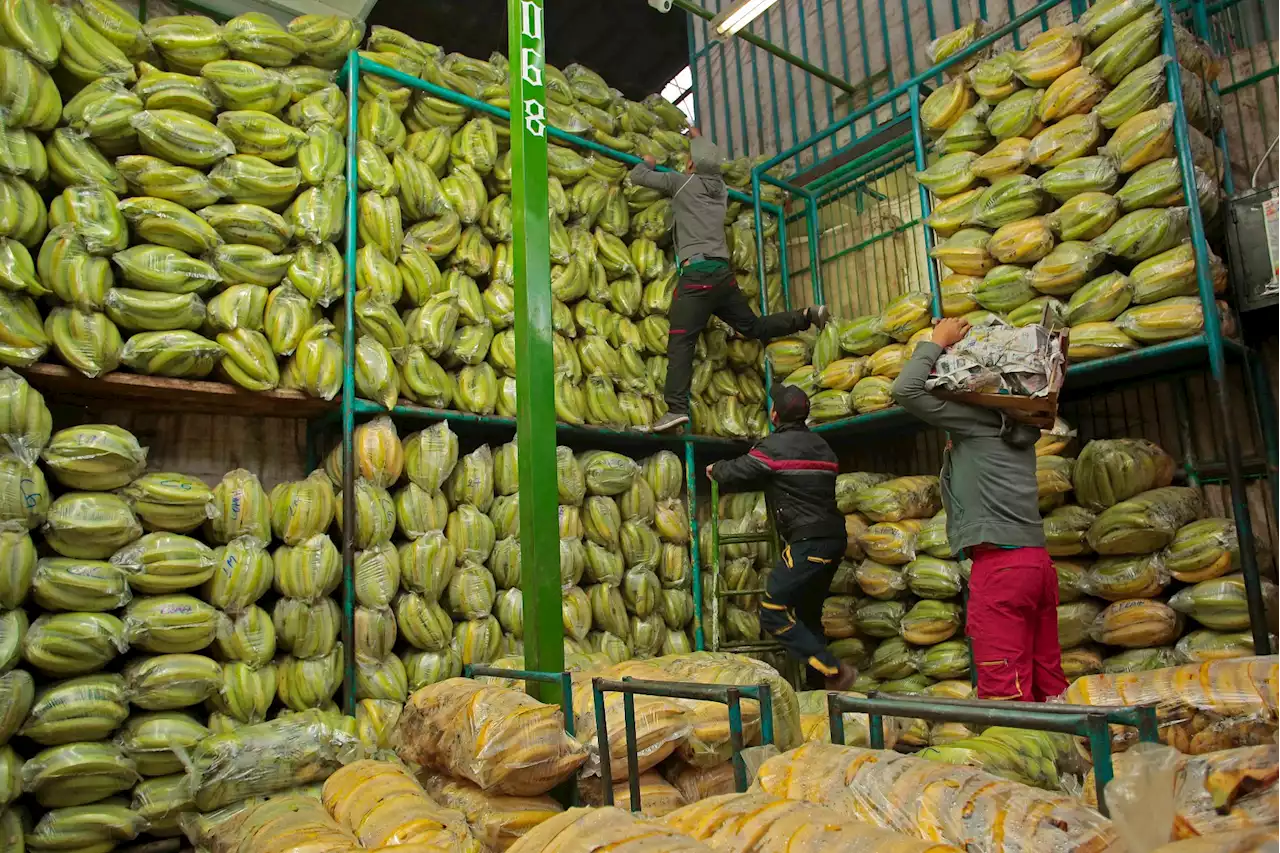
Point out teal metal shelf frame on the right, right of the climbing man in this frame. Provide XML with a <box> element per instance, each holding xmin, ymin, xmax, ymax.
<box><xmin>751</xmin><ymin>0</ymin><xmax>1280</xmax><ymax>654</ymax></box>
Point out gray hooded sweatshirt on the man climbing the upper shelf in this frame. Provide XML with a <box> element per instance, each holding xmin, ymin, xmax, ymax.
<box><xmin>631</xmin><ymin>137</ymin><xmax>730</xmax><ymax>261</ymax></box>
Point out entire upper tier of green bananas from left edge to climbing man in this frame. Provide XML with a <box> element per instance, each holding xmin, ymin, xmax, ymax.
<box><xmin>0</xmin><ymin>0</ymin><xmax>781</xmax><ymax>438</ymax></box>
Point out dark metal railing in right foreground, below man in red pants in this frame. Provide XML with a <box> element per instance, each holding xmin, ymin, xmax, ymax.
<box><xmin>827</xmin><ymin>693</ymin><xmax>1160</xmax><ymax>816</ymax></box>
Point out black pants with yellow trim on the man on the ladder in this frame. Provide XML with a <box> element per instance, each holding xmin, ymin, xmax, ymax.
<box><xmin>760</xmin><ymin>539</ymin><xmax>847</xmax><ymax>678</ymax></box>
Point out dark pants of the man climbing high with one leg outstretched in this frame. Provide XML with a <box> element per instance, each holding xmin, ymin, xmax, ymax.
<box><xmin>663</xmin><ymin>264</ymin><xmax>809</xmax><ymax>415</ymax></box>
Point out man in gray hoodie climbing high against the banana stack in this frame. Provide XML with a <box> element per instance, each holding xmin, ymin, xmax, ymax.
<box><xmin>630</xmin><ymin>128</ymin><xmax>828</xmax><ymax>433</ymax></box>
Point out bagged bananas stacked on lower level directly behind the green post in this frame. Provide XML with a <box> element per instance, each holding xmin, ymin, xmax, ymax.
<box><xmin>343</xmin><ymin>418</ymin><xmax>694</xmax><ymax>686</ymax></box>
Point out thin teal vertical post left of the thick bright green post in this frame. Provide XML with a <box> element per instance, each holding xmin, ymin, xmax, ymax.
<box><xmin>342</xmin><ymin>50</ymin><xmax>360</xmax><ymax>715</ymax></box>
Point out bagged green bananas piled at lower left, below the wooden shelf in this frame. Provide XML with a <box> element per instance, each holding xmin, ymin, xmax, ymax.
<box><xmin>0</xmin><ymin>370</ymin><xmax>376</xmax><ymax>849</ymax></box>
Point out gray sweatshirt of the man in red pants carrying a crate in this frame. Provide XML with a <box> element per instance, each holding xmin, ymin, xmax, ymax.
<box><xmin>893</xmin><ymin>342</ymin><xmax>1044</xmax><ymax>556</ymax></box>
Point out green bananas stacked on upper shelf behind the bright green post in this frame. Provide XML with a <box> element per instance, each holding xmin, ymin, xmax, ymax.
<box><xmin>355</xmin><ymin>27</ymin><xmax>781</xmax><ymax>437</ymax></box>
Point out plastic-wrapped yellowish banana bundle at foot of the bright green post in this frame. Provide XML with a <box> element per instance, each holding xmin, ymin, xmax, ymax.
<box><xmin>394</xmin><ymin>679</ymin><xmax>588</xmax><ymax>795</ymax></box>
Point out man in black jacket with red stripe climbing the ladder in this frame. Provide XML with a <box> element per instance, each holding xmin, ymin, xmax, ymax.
<box><xmin>707</xmin><ymin>386</ymin><xmax>858</xmax><ymax>690</ymax></box>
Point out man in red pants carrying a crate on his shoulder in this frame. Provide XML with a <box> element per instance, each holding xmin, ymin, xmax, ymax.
<box><xmin>893</xmin><ymin>318</ymin><xmax>1066</xmax><ymax>702</ymax></box>
